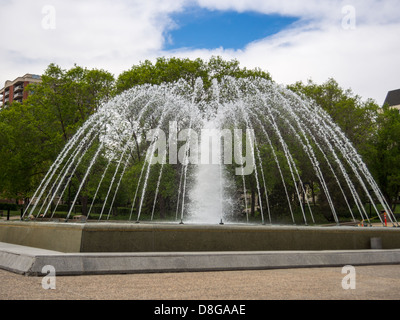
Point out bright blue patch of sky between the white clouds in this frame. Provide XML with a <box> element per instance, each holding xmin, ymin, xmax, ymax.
<box><xmin>164</xmin><ymin>7</ymin><xmax>298</xmax><ymax>50</ymax></box>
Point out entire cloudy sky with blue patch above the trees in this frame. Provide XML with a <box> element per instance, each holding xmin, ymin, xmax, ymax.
<box><xmin>0</xmin><ymin>0</ymin><xmax>400</xmax><ymax>104</ymax></box>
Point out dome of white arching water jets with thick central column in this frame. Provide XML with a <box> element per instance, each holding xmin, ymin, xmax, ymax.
<box><xmin>23</xmin><ymin>77</ymin><xmax>398</xmax><ymax>225</ymax></box>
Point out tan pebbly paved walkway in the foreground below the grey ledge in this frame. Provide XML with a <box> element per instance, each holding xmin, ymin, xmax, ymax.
<box><xmin>0</xmin><ymin>265</ymin><xmax>400</xmax><ymax>300</ymax></box>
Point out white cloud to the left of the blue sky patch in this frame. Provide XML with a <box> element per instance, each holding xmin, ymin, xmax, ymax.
<box><xmin>0</xmin><ymin>0</ymin><xmax>181</xmax><ymax>83</ymax></box>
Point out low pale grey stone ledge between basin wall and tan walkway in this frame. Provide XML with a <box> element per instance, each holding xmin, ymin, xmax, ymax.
<box><xmin>0</xmin><ymin>242</ymin><xmax>400</xmax><ymax>276</ymax></box>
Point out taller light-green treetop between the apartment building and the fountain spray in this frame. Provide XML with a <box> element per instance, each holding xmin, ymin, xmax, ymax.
<box><xmin>25</xmin><ymin>64</ymin><xmax>114</xmax><ymax>142</ymax></box>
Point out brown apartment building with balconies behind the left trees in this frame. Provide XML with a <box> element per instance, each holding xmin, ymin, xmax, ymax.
<box><xmin>0</xmin><ymin>73</ymin><xmax>41</xmax><ymax>108</ymax></box>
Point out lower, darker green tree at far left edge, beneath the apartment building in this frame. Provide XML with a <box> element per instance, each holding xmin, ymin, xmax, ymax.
<box><xmin>0</xmin><ymin>103</ymin><xmax>50</xmax><ymax>199</ymax></box>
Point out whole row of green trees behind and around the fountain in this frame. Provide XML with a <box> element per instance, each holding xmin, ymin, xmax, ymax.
<box><xmin>0</xmin><ymin>57</ymin><xmax>400</xmax><ymax>220</ymax></box>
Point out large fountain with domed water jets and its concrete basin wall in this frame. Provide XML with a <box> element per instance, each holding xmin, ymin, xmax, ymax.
<box><xmin>0</xmin><ymin>77</ymin><xmax>398</xmax><ymax>251</ymax></box>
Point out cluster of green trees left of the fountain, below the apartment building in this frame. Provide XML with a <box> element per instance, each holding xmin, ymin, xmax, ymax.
<box><xmin>0</xmin><ymin>64</ymin><xmax>114</xmax><ymax>202</ymax></box>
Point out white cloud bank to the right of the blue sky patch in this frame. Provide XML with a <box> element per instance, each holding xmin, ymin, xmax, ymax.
<box><xmin>179</xmin><ymin>0</ymin><xmax>400</xmax><ymax>104</ymax></box>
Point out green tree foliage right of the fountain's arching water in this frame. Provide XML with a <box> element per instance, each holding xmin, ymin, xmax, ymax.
<box><xmin>289</xmin><ymin>79</ymin><xmax>400</xmax><ymax>218</ymax></box>
